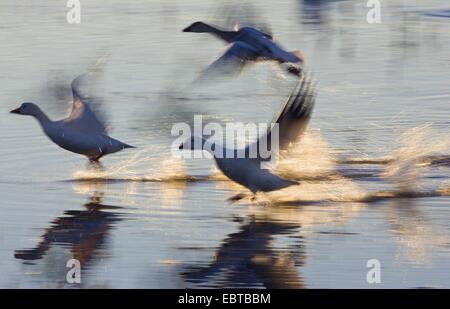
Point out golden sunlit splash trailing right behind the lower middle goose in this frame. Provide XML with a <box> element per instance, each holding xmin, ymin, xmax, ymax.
<box><xmin>227</xmin><ymin>125</ymin><xmax>450</xmax><ymax>205</ymax></box>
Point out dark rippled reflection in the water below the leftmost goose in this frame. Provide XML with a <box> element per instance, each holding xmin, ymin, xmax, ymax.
<box><xmin>14</xmin><ymin>191</ymin><xmax>120</xmax><ymax>266</ymax></box>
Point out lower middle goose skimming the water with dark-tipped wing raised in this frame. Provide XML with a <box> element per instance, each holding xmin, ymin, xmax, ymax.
<box><xmin>179</xmin><ymin>77</ymin><xmax>315</xmax><ymax>195</ymax></box>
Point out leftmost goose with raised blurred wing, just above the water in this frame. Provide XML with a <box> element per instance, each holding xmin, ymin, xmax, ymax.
<box><xmin>10</xmin><ymin>75</ymin><xmax>135</xmax><ymax>162</ymax></box>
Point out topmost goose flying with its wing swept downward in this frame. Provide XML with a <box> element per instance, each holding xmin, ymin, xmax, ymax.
<box><xmin>183</xmin><ymin>21</ymin><xmax>304</xmax><ymax>76</ymax></box>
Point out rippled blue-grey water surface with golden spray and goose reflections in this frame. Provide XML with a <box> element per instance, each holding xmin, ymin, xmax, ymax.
<box><xmin>0</xmin><ymin>0</ymin><xmax>450</xmax><ymax>288</ymax></box>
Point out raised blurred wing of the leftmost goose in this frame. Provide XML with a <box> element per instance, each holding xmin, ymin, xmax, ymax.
<box><xmin>64</xmin><ymin>74</ymin><xmax>107</xmax><ymax>134</ymax></box>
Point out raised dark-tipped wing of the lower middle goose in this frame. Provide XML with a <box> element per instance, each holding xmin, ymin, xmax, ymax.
<box><xmin>249</xmin><ymin>77</ymin><xmax>316</xmax><ymax>160</ymax></box>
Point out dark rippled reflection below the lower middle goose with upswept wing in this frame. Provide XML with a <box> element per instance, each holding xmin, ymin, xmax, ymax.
<box><xmin>182</xmin><ymin>220</ymin><xmax>304</xmax><ymax>288</ymax></box>
